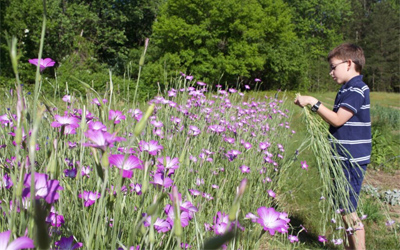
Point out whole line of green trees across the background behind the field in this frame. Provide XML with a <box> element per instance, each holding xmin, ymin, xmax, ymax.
<box><xmin>0</xmin><ymin>0</ymin><xmax>400</xmax><ymax>97</ymax></box>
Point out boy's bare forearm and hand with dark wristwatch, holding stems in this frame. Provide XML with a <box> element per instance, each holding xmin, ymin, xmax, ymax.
<box><xmin>294</xmin><ymin>96</ymin><xmax>353</xmax><ymax>127</ymax></box>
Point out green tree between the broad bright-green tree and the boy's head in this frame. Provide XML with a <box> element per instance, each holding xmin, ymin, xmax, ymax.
<box><xmin>285</xmin><ymin>0</ymin><xmax>351</xmax><ymax>90</ymax></box>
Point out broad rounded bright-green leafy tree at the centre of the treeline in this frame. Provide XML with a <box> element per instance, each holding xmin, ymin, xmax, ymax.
<box><xmin>152</xmin><ymin>0</ymin><xmax>304</xmax><ymax>87</ymax></box>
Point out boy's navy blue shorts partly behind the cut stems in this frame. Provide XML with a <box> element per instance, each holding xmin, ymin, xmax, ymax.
<box><xmin>341</xmin><ymin>161</ymin><xmax>367</xmax><ymax>214</ymax></box>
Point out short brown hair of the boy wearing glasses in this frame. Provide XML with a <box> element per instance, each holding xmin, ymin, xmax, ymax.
<box><xmin>328</xmin><ymin>43</ymin><xmax>365</xmax><ymax>73</ymax></box>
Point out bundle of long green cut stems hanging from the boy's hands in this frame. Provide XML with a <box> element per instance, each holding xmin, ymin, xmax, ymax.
<box><xmin>297</xmin><ymin>94</ymin><xmax>363</xmax><ymax>237</ymax></box>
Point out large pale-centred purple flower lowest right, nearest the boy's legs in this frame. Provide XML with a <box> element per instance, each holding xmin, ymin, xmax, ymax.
<box><xmin>257</xmin><ymin>207</ymin><xmax>290</xmax><ymax>235</ymax></box>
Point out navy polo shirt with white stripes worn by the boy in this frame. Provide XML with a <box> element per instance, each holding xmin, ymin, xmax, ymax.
<box><xmin>329</xmin><ymin>75</ymin><xmax>372</xmax><ymax>165</ymax></box>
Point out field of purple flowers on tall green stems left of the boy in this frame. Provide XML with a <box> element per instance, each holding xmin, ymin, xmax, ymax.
<box><xmin>0</xmin><ymin>66</ymin><xmax>307</xmax><ymax>249</ymax></box>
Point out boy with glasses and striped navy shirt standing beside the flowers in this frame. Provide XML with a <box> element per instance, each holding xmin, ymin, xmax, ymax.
<box><xmin>294</xmin><ymin>43</ymin><xmax>371</xmax><ymax>249</ymax></box>
